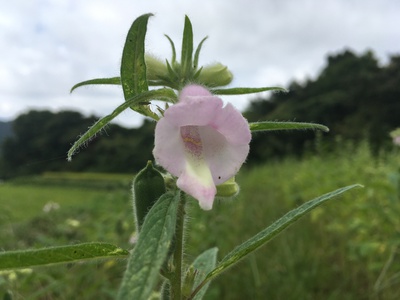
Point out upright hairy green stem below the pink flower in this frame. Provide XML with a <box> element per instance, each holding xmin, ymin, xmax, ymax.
<box><xmin>170</xmin><ymin>192</ymin><xmax>186</xmax><ymax>300</ymax></box>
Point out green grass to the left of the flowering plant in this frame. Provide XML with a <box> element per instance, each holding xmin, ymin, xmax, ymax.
<box><xmin>0</xmin><ymin>174</ymin><xmax>135</xmax><ymax>299</ymax></box>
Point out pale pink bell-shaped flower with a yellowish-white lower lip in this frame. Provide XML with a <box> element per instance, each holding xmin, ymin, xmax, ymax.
<box><xmin>153</xmin><ymin>85</ymin><xmax>251</xmax><ymax>210</ymax></box>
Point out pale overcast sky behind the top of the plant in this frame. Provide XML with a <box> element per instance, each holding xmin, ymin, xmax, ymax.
<box><xmin>0</xmin><ymin>0</ymin><xmax>400</xmax><ymax>126</ymax></box>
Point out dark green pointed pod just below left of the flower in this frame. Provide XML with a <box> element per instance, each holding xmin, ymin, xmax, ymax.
<box><xmin>132</xmin><ymin>161</ymin><xmax>166</xmax><ymax>231</ymax></box>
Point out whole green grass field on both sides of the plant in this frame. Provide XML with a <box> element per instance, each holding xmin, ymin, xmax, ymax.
<box><xmin>0</xmin><ymin>145</ymin><xmax>400</xmax><ymax>299</ymax></box>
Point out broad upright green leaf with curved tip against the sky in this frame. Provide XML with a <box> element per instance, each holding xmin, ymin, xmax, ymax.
<box><xmin>121</xmin><ymin>14</ymin><xmax>152</xmax><ymax>100</ymax></box>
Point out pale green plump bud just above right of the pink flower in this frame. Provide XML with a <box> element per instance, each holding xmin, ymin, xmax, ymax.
<box><xmin>197</xmin><ymin>63</ymin><xmax>233</xmax><ymax>87</ymax></box>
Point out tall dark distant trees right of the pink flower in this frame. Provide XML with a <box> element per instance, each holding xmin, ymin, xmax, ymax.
<box><xmin>244</xmin><ymin>50</ymin><xmax>400</xmax><ymax>163</ymax></box>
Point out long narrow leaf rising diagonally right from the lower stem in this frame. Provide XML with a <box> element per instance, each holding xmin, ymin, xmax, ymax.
<box><xmin>202</xmin><ymin>184</ymin><xmax>362</xmax><ymax>284</ymax></box>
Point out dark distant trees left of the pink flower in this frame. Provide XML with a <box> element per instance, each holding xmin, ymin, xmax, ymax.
<box><xmin>0</xmin><ymin>110</ymin><xmax>155</xmax><ymax>178</ymax></box>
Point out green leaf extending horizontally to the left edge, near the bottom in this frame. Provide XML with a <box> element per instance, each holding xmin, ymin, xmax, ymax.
<box><xmin>0</xmin><ymin>243</ymin><xmax>129</xmax><ymax>270</ymax></box>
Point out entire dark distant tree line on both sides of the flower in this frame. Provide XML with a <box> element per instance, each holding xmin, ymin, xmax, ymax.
<box><xmin>0</xmin><ymin>50</ymin><xmax>400</xmax><ymax>178</ymax></box>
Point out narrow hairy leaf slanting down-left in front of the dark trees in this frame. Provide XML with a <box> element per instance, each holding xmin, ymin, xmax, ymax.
<box><xmin>68</xmin><ymin>89</ymin><xmax>176</xmax><ymax>161</ymax></box>
